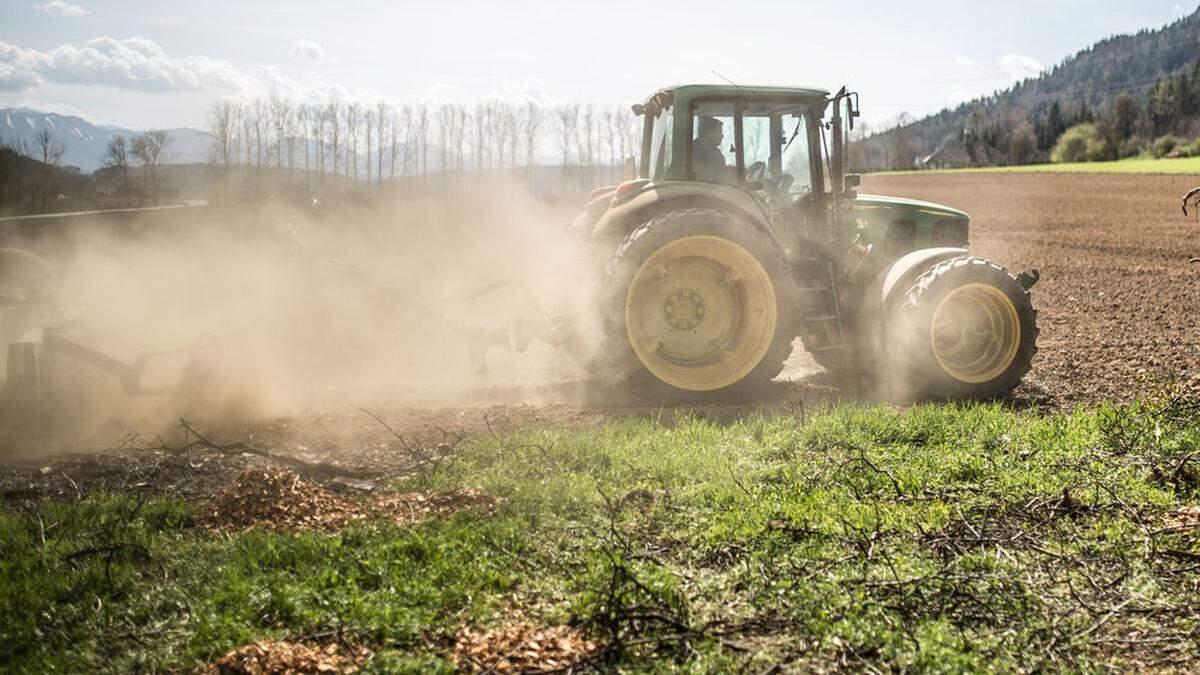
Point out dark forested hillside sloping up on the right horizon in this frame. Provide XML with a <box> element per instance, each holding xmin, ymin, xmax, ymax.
<box><xmin>859</xmin><ymin>10</ymin><xmax>1200</xmax><ymax>168</ymax></box>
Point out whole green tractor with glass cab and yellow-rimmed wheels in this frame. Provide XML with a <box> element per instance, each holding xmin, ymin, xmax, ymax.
<box><xmin>571</xmin><ymin>85</ymin><xmax>1038</xmax><ymax>400</ymax></box>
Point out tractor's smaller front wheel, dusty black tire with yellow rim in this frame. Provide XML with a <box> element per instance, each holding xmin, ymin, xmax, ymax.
<box><xmin>886</xmin><ymin>256</ymin><xmax>1038</xmax><ymax>400</ymax></box>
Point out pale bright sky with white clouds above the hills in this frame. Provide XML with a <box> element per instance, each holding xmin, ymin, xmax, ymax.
<box><xmin>0</xmin><ymin>0</ymin><xmax>1196</xmax><ymax>129</ymax></box>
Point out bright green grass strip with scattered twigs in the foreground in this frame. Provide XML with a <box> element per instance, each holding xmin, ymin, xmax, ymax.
<box><xmin>0</xmin><ymin>405</ymin><xmax>1200</xmax><ymax>673</ymax></box>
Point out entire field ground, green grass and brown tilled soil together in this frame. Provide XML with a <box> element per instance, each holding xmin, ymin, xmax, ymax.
<box><xmin>0</xmin><ymin>173</ymin><xmax>1200</xmax><ymax>673</ymax></box>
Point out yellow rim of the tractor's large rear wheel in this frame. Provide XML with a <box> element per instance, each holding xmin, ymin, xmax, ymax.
<box><xmin>625</xmin><ymin>235</ymin><xmax>779</xmax><ymax>392</ymax></box>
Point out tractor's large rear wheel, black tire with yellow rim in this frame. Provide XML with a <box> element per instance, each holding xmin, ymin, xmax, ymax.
<box><xmin>602</xmin><ymin>208</ymin><xmax>797</xmax><ymax>401</ymax></box>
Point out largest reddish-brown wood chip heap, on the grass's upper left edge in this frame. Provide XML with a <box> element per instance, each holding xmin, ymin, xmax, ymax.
<box><xmin>199</xmin><ymin>466</ymin><xmax>499</xmax><ymax>533</ymax></box>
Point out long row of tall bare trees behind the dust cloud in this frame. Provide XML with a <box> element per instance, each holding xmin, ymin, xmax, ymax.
<box><xmin>206</xmin><ymin>95</ymin><xmax>641</xmax><ymax>199</ymax></box>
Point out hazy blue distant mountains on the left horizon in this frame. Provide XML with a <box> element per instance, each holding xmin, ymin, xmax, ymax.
<box><xmin>0</xmin><ymin>108</ymin><xmax>212</xmax><ymax>173</ymax></box>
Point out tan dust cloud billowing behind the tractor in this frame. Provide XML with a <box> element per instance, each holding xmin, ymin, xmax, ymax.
<box><xmin>6</xmin><ymin>182</ymin><xmax>609</xmax><ymax>449</ymax></box>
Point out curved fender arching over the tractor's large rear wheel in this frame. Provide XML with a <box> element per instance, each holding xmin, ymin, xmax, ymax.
<box><xmin>590</xmin><ymin>181</ymin><xmax>782</xmax><ymax>246</ymax></box>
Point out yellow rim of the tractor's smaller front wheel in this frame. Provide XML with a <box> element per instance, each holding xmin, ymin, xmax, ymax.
<box><xmin>930</xmin><ymin>283</ymin><xmax>1021</xmax><ymax>384</ymax></box>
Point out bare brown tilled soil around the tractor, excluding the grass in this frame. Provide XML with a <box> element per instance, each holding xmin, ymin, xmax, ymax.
<box><xmin>0</xmin><ymin>173</ymin><xmax>1200</xmax><ymax>502</ymax></box>
